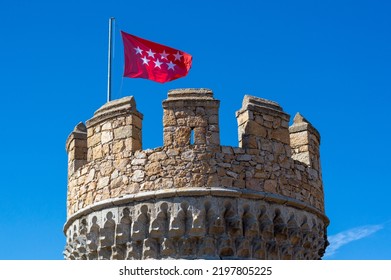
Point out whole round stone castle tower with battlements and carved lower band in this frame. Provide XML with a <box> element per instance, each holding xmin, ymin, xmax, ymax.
<box><xmin>64</xmin><ymin>89</ymin><xmax>329</xmax><ymax>259</ymax></box>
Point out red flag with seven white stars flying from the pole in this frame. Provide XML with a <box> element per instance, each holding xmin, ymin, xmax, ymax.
<box><xmin>121</xmin><ymin>31</ymin><xmax>192</xmax><ymax>83</ymax></box>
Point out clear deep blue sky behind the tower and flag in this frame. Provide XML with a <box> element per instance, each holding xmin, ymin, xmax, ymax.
<box><xmin>0</xmin><ymin>0</ymin><xmax>391</xmax><ymax>259</ymax></box>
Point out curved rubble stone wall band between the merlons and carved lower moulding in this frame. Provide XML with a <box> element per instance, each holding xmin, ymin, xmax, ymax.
<box><xmin>67</xmin><ymin>144</ymin><xmax>324</xmax><ymax>216</ymax></box>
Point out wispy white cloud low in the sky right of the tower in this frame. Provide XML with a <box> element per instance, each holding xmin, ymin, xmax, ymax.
<box><xmin>325</xmin><ymin>224</ymin><xmax>384</xmax><ymax>257</ymax></box>
